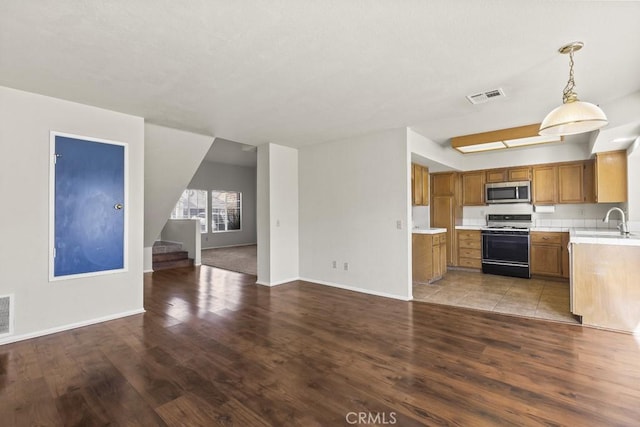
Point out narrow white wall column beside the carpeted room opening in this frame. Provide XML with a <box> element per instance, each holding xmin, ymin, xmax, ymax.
<box><xmin>257</xmin><ymin>144</ymin><xmax>299</xmax><ymax>286</ymax></box>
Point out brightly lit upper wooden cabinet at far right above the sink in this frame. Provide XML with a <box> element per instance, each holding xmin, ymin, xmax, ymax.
<box><xmin>595</xmin><ymin>150</ymin><xmax>627</xmax><ymax>203</ymax></box>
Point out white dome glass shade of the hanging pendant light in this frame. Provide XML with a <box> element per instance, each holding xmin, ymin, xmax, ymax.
<box><xmin>540</xmin><ymin>101</ymin><xmax>609</xmax><ymax>135</ymax></box>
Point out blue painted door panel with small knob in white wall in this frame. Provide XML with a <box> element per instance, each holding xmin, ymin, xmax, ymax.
<box><xmin>54</xmin><ymin>135</ymin><xmax>126</xmax><ymax>277</ymax></box>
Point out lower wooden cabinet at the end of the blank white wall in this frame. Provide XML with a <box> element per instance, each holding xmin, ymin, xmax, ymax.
<box><xmin>411</xmin><ymin>233</ymin><xmax>447</xmax><ymax>283</ymax></box>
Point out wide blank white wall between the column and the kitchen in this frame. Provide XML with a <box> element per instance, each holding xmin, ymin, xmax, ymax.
<box><xmin>299</xmin><ymin>129</ymin><xmax>411</xmax><ymax>299</ymax></box>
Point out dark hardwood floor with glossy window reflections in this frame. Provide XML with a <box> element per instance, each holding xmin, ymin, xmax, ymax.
<box><xmin>0</xmin><ymin>266</ymin><xmax>640</xmax><ymax>426</ymax></box>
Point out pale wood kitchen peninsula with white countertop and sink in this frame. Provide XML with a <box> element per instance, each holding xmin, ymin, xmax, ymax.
<box><xmin>569</xmin><ymin>229</ymin><xmax>640</xmax><ymax>333</ymax></box>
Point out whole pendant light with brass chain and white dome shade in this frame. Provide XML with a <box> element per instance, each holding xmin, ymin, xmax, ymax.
<box><xmin>540</xmin><ymin>42</ymin><xmax>609</xmax><ymax>135</ymax></box>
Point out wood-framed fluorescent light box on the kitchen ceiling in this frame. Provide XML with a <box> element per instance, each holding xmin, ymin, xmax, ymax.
<box><xmin>451</xmin><ymin>123</ymin><xmax>564</xmax><ymax>154</ymax></box>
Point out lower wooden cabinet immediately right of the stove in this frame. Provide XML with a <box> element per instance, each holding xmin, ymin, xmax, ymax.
<box><xmin>530</xmin><ymin>231</ymin><xmax>569</xmax><ymax>278</ymax></box>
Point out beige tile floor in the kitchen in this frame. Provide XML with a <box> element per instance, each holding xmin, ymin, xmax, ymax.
<box><xmin>413</xmin><ymin>270</ymin><xmax>578</xmax><ymax>324</ymax></box>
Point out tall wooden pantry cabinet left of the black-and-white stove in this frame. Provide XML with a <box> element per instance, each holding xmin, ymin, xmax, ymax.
<box><xmin>430</xmin><ymin>172</ymin><xmax>462</xmax><ymax>266</ymax></box>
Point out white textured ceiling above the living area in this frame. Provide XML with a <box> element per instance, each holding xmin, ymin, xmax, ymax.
<box><xmin>0</xmin><ymin>0</ymin><xmax>640</xmax><ymax>147</ymax></box>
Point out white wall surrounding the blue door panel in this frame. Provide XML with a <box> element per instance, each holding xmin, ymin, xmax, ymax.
<box><xmin>0</xmin><ymin>87</ymin><xmax>144</xmax><ymax>342</ymax></box>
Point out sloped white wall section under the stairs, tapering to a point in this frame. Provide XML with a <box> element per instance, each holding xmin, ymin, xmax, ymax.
<box><xmin>144</xmin><ymin>123</ymin><xmax>214</xmax><ymax>251</ymax></box>
